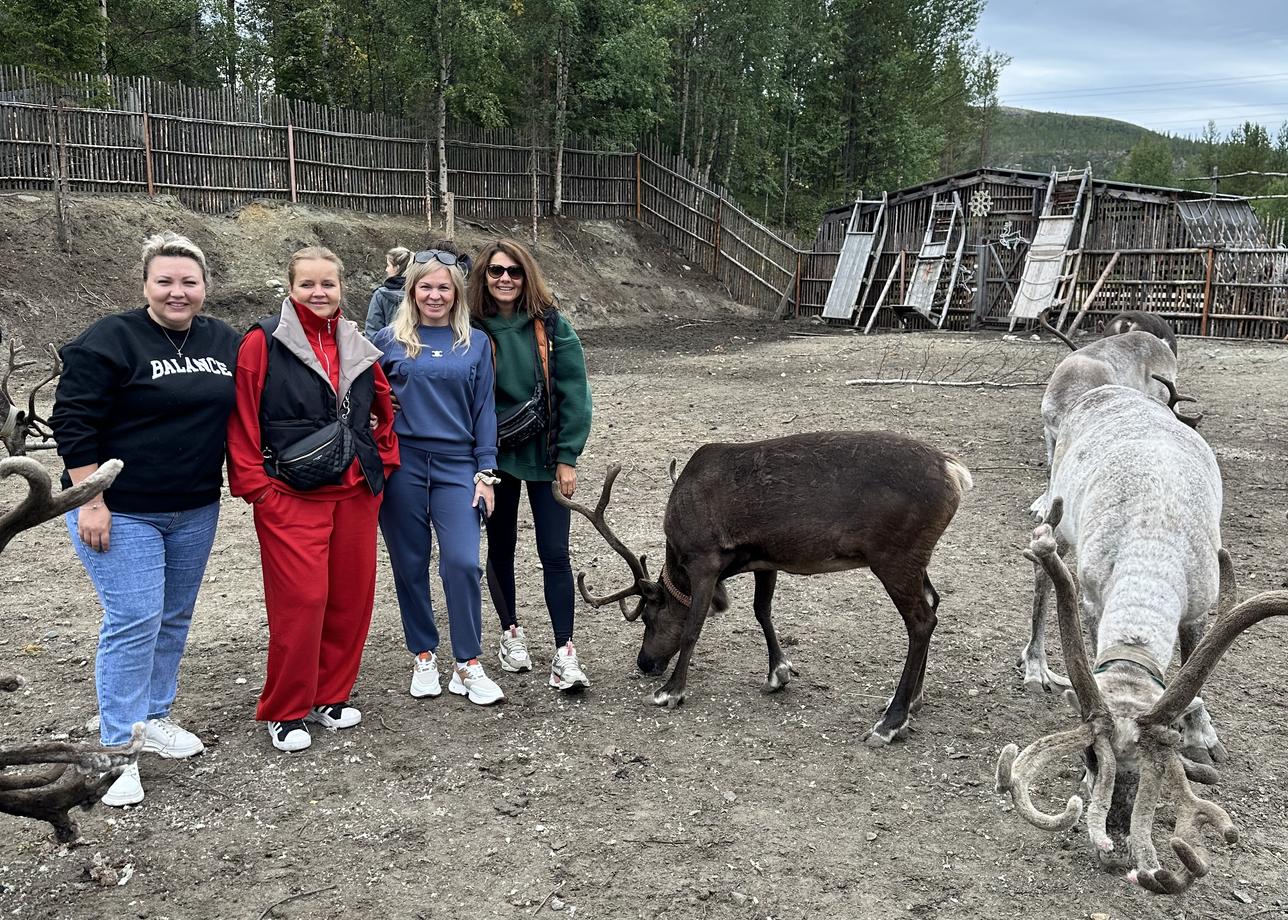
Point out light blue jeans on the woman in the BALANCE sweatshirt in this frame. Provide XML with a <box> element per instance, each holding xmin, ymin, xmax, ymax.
<box><xmin>64</xmin><ymin>501</ymin><xmax>219</xmax><ymax>745</ymax></box>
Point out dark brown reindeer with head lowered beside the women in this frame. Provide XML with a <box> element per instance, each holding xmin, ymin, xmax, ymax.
<box><xmin>554</xmin><ymin>432</ymin><xmax>972</xmax><ymax>746</ymax></box>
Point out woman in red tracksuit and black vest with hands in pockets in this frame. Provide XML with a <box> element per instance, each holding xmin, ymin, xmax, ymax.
<box><xmin>228</xmin><ymin>246</ymin><xmax>398</xmax><ymax>751</ymax></box>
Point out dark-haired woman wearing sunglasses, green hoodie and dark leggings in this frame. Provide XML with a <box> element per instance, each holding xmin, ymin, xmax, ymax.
<box><xmin>469</xmin><ymin>240</ymin><xmax>590</xmax><ymax>692</ymax></box>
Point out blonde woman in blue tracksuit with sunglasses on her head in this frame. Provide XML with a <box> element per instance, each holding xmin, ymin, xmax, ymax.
<box><xmin>375</xmin><ymin>249</ymin><xmax>505</xmax><ymax>706</ymax></box>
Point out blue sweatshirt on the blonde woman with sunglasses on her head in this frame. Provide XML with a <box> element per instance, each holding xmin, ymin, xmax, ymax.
<box><xmin>375</xmin><ymin>326</ymin><xmax>496</xmax><ymax>470</ymax></box>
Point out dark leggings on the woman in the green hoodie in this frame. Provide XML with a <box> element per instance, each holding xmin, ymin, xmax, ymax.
<box><xmin>487</xmin><ymin>473</ymin><xmax>573</xmax><ymax>648</ymax></box>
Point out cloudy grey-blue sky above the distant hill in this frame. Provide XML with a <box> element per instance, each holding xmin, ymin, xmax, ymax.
<box><xmin>976</xmin><ymin>0</ymin><xmax>1288</xmax><ymax>138</ymax></box>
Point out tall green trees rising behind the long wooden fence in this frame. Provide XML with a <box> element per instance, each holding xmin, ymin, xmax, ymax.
<box><xmin>0</xmin><ymin>0</ymin><xmax>1005</xmax><ymax>227</ymax></box>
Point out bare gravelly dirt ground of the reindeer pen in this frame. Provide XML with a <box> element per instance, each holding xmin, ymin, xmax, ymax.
<box><xmin>0</xmin><ymin>197</ymin><xmax>1288</xmax><ymax>920</ymax></box>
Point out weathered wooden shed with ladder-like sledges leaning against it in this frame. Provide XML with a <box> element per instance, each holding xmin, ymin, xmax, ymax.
<box><xmin>799</xmin><ymin>168</ymin><xmax>1288</xmax><ymax>339</ymax></box>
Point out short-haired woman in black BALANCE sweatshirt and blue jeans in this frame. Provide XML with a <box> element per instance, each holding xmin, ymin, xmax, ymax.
<box><xmin>50</xmin><ymin>233</ymin><xmax>238</xmax><ymax>807</ymax></box>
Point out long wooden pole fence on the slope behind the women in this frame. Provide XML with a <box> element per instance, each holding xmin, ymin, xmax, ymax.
<box><xmin>0</xmin><ymin>67</ymin><xmax>805</xmax><ymax>312</ymax></box>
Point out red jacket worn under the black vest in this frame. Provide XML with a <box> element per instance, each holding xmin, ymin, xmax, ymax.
<box><xmin>228</xmin><ymin>299</ymin><xmax>398</xmax><ymax>503</ymax></box>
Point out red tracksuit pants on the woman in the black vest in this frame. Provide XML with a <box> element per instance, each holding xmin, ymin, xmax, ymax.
<box><xmin>254</xmin><ymin>486</ymin><xmax>380</xmax><ymax>722</ymax></box>
